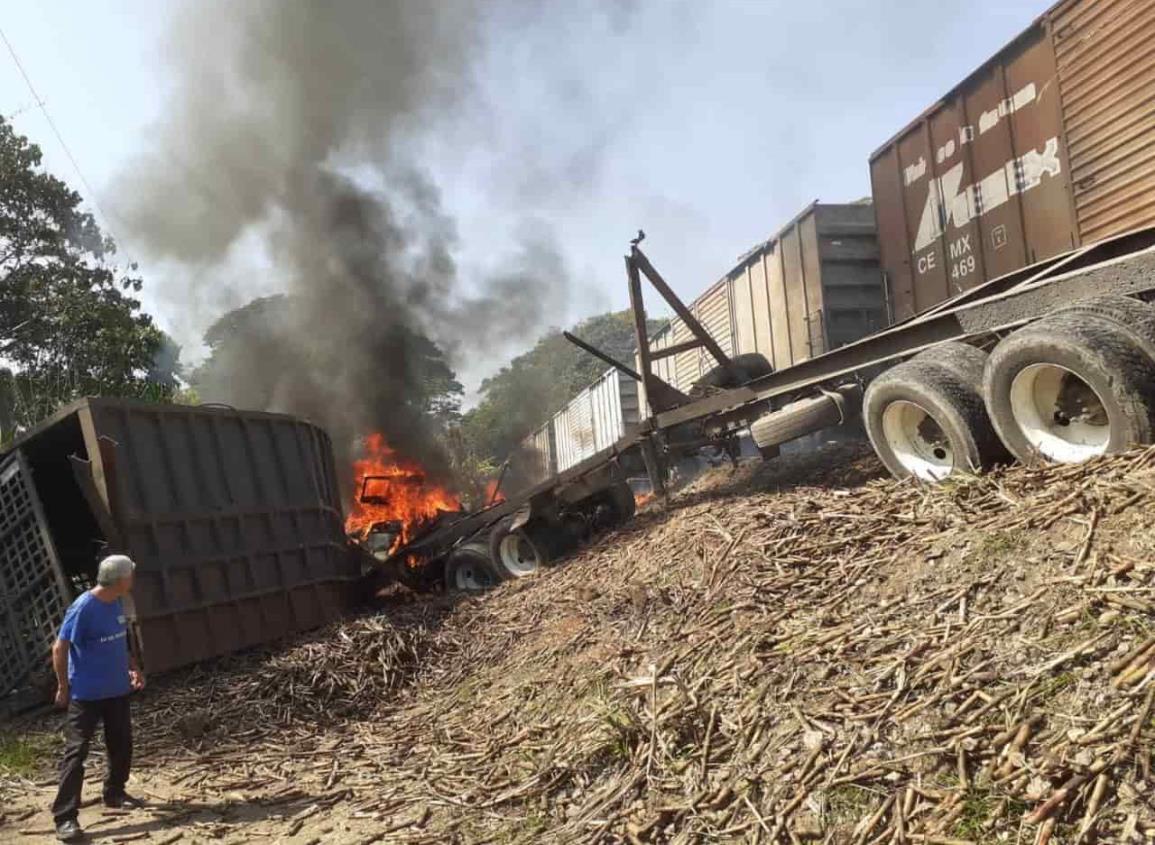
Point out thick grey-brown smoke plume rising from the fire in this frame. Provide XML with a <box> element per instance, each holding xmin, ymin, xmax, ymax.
<box><xmin>121</xmin><ymin>0</ymin><xmax>565</xmax><ymax>477</ymax></box>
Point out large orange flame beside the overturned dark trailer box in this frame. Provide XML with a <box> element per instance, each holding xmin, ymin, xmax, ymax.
<box><xmin>345</xmin><ymin>433</ymin><xmax>461</xmax><ymax>549</ymax></box>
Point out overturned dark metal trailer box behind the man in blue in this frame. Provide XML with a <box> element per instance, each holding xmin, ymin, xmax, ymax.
<box><xmin>3</xmin><ymin>399</ymin><xmax>359</xmax><ymax>688</ymax></box>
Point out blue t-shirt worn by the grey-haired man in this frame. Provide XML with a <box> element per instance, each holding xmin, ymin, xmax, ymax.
<box><xmin>60</xmin><ymin>592</ymin><xmax>132</xmax><ymax>701</ymax></box>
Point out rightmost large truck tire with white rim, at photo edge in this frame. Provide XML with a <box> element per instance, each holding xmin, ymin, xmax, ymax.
<box><xmin>984</xmin><ymin>308</ymin><xmax>1155</xmax><ymax>463</ymax></box>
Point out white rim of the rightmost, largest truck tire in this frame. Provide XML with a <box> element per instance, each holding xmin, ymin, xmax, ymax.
<box><xmin>1011</xmin><ymin>364</ymin><xmax>1111</xmax><ymax>464</ymax></box>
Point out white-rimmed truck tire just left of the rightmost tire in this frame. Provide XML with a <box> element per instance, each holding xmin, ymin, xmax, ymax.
<box><xmin>863</xmin><ymin>350</ymin><xmax>1006</xmax><ymax>481</ymax></box>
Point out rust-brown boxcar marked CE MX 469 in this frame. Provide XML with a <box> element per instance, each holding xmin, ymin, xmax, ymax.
<box><xmin>871</xmin><ymin>0</ymin><xmax>1155</xmax><ymax>320</ymax></box>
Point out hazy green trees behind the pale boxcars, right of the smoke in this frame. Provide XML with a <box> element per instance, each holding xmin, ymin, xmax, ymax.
<box><xmin>462</xmin><ymin>311</ymin><xmax>663</xmax><ymax>462</ymax></box>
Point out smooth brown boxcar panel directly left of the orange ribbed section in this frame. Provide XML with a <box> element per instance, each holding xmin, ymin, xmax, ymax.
<box><xmin>1004</xmin><ymin>30</ymin><xmax>1079</xmax><ymax>264</ymax></box>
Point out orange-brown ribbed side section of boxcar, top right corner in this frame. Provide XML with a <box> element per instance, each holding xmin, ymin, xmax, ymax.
<box><xmin>1052</xmin><ymin>0</ymin><xmax>1155</xmax><ymax>242</ymax></box>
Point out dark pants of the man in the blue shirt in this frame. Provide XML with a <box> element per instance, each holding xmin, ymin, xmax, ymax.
<box><xmin>52</xmin><ymin>695</ymin><xmax>133</xmax><ymax>824</ymax></box>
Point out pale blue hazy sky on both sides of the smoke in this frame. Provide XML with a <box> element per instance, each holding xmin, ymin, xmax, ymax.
<box><xmin>0</xmin><ymin>0</ymin><xmax>1046</xmax><ymax>387</ymax></box>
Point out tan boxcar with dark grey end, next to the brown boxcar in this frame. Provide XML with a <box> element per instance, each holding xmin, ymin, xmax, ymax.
<box><xmin>650</xmin><ymin>202</ymin><xmax>887</xmax><ymax>391</ymax></box>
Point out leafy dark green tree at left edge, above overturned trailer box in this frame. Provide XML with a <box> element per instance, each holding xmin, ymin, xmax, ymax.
<box><xmin>0</xmin><ymin>118</ymin><xmax>164</xmax><ymax>436</ymax></box>
